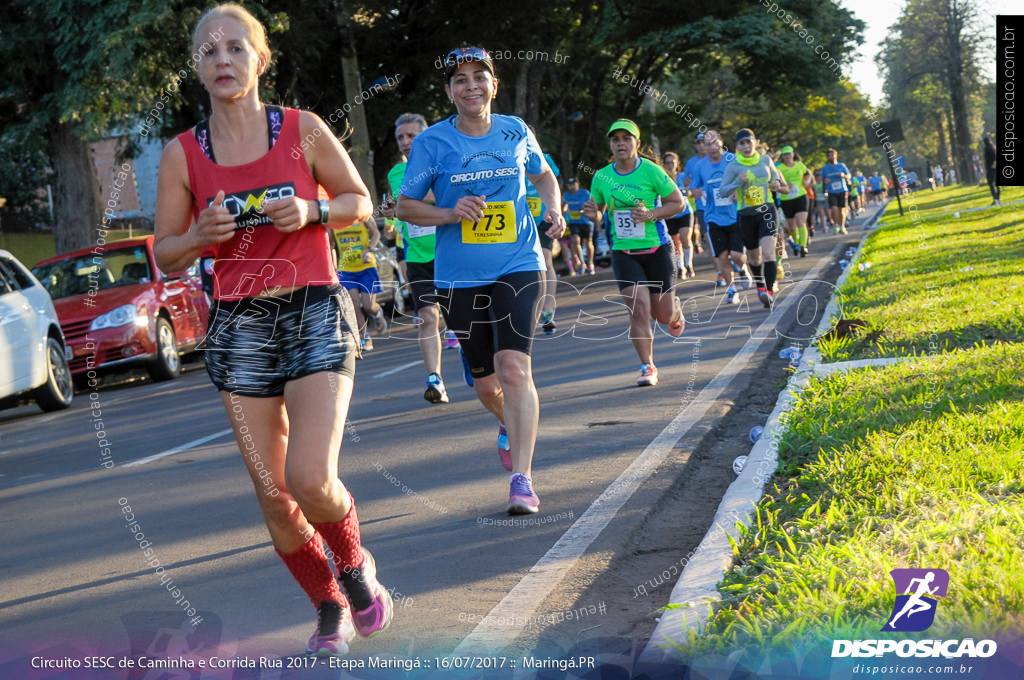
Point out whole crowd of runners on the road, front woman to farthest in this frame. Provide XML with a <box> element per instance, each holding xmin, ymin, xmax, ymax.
<box><xmin>155</xmin><ymin>4</ymin><xmax>885</xmax><ymax>654</ymax></box>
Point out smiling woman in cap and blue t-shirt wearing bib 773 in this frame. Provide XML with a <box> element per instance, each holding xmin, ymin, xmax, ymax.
<box><xmin>397</xmin><ymin>47</ymin><xmax>565</xmax><ymax>514</ymax></box>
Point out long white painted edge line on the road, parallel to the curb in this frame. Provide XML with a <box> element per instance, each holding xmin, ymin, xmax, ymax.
<box><xmin>452</xmin><ymin>255</ymin><xmax>831</xmax><ymax>655</ymax></box>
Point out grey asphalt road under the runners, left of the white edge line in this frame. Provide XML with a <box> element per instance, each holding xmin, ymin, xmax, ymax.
<box><xmin>0</xmin><ymin>215</ymin><xmax>876</xmax><ymax>678</ymax></box>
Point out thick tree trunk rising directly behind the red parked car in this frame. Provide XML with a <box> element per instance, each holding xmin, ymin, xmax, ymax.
<box><xmin>49</xmin><ymin>123</ymin><xmax>103</xmax><ymax>253</ymax></box>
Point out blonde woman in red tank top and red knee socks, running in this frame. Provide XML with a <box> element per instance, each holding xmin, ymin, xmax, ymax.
<box><xmin>155</xmin><ymin>4</ymin><xmax>392</xmax><ymax>654</ymax></box>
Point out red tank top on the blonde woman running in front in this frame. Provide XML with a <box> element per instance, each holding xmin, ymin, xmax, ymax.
<box><xmin>178</xmin><ymin>109</ymin><xmax>338</xmax><ymax>300</ymax></box>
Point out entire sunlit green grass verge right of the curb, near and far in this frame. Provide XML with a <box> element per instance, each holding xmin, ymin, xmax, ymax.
<box><xmin>666</xmin><ymin>182</ymin><xmax>1024</xmax><ymax>668</ymax></box>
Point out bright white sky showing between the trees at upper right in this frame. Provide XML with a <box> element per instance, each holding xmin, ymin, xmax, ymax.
<box><xmin>841</xmin><ymin>0</ymin><xmax>1007</xmax><ymax>107</ymax></box>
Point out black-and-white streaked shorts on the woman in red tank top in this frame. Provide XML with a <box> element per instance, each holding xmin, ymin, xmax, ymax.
<box><xmin>201</xmin><ymin>286</ymin><xmax>358</xmax><ymax>397</ymax></box>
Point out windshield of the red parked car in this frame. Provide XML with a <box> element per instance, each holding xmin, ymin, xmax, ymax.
<box><xmin>32</xmin><ymin>246</ymin><xmax>153</xmax><ymax>300</ymax></box>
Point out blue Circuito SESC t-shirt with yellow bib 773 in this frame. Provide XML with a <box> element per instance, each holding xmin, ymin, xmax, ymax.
<box><xmin>401</xmin><ymin>114</ymin><xmax>546</xmax><ymax>288</ymax></box>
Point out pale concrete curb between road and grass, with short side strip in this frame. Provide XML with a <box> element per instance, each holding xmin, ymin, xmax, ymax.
<box><xmin>637</xmin><ymin>199</ymin><xmax>888</xmax><ymax>669</ymax></box>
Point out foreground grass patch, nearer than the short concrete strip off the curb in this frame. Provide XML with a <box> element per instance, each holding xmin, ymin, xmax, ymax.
<box><xmin>682</xmin><ymin>343</ymin><xmax>1024</xmax><ymax>662</ymax></box>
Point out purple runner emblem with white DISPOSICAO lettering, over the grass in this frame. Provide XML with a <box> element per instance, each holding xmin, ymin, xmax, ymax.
<box><xmin>831</xmin><ymin>569</ymin><xmax>996</xmax><ymax>658</ymax></box>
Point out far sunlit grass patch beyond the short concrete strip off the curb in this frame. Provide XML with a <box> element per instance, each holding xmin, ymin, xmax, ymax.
<box><xmin>821</xmin><ymin>186</ymin><xmax>1024</xmax><ymax>362</ymax></box>
